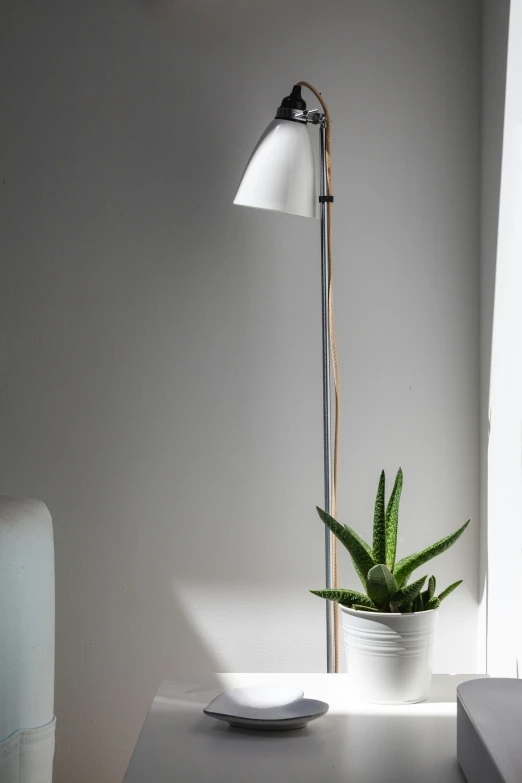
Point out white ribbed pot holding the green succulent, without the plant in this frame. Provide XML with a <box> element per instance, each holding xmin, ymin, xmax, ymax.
<box><xmin>339</xmin><ymin>606</ymin><xmax>438</xmax><ymax>704</ymax></box>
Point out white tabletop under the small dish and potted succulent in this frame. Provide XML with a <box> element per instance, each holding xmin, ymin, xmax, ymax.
<box><xmin>124</xmin><ymin>674</ymin><xmax>482</xmax><ymax>783</ymax></box>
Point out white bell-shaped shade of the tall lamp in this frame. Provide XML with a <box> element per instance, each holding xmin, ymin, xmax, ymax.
<box><xmin>234</xmin><ymin>119</ymin><xmax>319</xmax><ymax>218</ymax></box>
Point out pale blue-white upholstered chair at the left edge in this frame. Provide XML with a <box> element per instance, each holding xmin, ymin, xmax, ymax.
<box><xmin>0</xmin><ymin>496</ymin><xmax>55</xmax><ymax>783</ymax></box>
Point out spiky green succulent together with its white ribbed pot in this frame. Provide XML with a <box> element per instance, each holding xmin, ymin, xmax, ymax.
<box><xmin>310</xmin><ymin>468</ymin><xmax>470</xmax><ymax>704</ymax></box>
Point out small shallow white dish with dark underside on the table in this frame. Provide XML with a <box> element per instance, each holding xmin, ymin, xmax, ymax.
<box><xmin>204</xmin><ymin>685</ymin><xmax>328</xmax><ymax>731</ymax></box>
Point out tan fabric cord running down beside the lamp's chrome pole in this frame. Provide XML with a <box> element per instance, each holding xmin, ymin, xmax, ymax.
<box><xmin>297</xmin><ymin>82</ymin><xmax>341</xmax><ymax>672</ymax></box>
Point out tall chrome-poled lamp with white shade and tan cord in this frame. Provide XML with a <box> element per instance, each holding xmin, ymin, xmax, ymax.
<box><xmin>234</xmin><ymin>82</ymin><xmax>339</xmax><ymax>672</ymax></box>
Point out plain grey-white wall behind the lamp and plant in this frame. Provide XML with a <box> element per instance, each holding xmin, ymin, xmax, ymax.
<box><xmin>0</xmin><ymin>0</ymin><xmax>479</xmax><ymax>783</ymax></box>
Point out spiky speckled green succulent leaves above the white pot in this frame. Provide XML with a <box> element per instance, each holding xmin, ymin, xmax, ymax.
<box><xmin>310</xmin><ymin>468</ymin><xmax>470</xmax><ymax>613</ymax></box>
